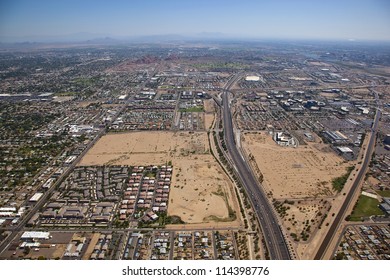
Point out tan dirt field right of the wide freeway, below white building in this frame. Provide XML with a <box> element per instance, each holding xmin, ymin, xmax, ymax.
<box><xmin>243</xmin><ymin>132</ymin><xmax>349</xmax><ymax>199</ymax></box>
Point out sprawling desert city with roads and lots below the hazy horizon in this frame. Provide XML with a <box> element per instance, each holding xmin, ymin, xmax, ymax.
<box><xmin>0</xmin><ymin>1</ymin><xmax>390</xmax><ymax>260</ymax></box>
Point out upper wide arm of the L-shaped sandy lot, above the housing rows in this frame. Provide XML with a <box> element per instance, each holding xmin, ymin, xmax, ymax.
<box><xmin>80</xmin><ymin>131</ymin><xmax>208</xmax><ymax>165</ymax></box>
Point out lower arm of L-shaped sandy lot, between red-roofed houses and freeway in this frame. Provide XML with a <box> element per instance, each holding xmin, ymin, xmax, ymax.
<box><xmin>168</xmin><ymin>155</ymin><xmax>234</xmax><ymax>223</ymax></box>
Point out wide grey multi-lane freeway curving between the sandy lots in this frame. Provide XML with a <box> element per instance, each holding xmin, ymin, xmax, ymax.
<box><xmin>222</xmin><ymin>75</ymin><xmax>290</xmax><ymax>260</ymax></box>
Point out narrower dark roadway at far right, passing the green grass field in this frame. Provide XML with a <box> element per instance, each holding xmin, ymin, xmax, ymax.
<box><xmin>314</xmin><ymin>106</ymin><xmax>381</xmax><ymax>260</ymax></box>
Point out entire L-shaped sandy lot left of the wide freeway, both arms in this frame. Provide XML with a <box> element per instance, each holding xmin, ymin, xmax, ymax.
<box><xmin>80</xmin><ymin>132</ymin><xmax>239</xmax><ymax>224</ymax></box>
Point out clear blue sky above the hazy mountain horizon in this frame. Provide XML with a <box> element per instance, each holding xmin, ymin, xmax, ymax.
<box><xmin>0</xmin><ymin>0</ymin><xmax>390</xmax><ymax>41</ymax></box>
